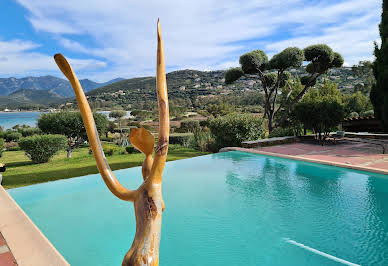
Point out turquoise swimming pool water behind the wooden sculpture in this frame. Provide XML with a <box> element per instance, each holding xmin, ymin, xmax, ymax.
<box><xmin>8</xmin><ymin>152</ymin><xmax>388</xmax><ymax>265</ymax></box>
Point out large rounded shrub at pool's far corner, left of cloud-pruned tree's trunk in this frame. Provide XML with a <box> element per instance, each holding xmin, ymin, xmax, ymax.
<box><xmin>209</xmin><ymin>113</ymin><xmax>265</xmax><ymax>148</ymax></box>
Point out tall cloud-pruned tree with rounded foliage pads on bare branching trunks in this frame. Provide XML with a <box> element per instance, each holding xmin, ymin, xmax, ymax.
<box><xmin>225</xmin><ymin>44</ymin><xmax>343</xmax><ymax>133</ymax></box>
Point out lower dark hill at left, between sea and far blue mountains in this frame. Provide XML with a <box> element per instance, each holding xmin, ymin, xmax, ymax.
<box><xmin>0</xmin><ymin>89</ymin><xmax>65</xmax><ymax>108</ymax></box>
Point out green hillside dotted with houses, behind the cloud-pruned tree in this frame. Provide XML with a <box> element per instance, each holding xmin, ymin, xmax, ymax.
<box><xmin>87</xmin><ymin>67</ymin><xmax>363</xmax><ymax>104</ymax></box>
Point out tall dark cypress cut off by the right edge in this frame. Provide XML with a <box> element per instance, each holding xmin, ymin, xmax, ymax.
<box><xmin>370</xmin><ymin>0</ymin><xmax>388</xmax><ymax>131</ymax></box>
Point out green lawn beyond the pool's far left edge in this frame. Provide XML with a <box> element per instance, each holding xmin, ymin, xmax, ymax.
<box><xmin>0</xmin><ymin>145</ymin><xmax>207</xmax><ymax>188</ymax></box>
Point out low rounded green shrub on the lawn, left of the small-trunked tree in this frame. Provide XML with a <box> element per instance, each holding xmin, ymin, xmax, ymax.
<box><xmin>19</xmin><ymin>135</ymin><xmax>67</xmax><ymax>163</ymax></box>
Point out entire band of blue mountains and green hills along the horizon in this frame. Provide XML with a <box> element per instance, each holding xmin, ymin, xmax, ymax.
<box><xmin>0</xmin><ymin>67</ymin><xmax>366</xmax><ymax>109</ymax></box>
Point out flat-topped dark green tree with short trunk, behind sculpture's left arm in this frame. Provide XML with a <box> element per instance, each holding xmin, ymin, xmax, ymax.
<box><xmin>38</xmin><ymin>112</ymin><xmax>108</xmax><ymax>158</ymax></box>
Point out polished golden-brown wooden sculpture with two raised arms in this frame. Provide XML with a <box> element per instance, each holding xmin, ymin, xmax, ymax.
<box><xmin>54</xmin><ymin>20</ymin><xmax>170</xmax><ymax>265</ymax></box>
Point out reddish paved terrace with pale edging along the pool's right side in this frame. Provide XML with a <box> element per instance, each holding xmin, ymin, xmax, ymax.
<box><xmin>224</xmin><ymin>141</ymin><xmax>388</xmax><ymax>175</ymax></box>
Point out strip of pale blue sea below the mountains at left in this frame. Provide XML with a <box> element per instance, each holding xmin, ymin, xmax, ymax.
<box><xmin>0</xmin><ymin>111</ymin><xmax>131</xmax><ymax>129</ymax></box>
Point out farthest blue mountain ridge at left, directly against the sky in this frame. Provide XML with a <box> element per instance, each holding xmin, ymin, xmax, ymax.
<box><xmin>0</xmin><ymin>76</ymin><xmax>122</xmax><ymax>97</ymax></box>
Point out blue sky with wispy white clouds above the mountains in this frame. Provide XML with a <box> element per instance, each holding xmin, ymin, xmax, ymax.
<box><xmin>0</xmin><ymin>0</ymin><xmax>382</xmax><ymax>82</ymax></box>
